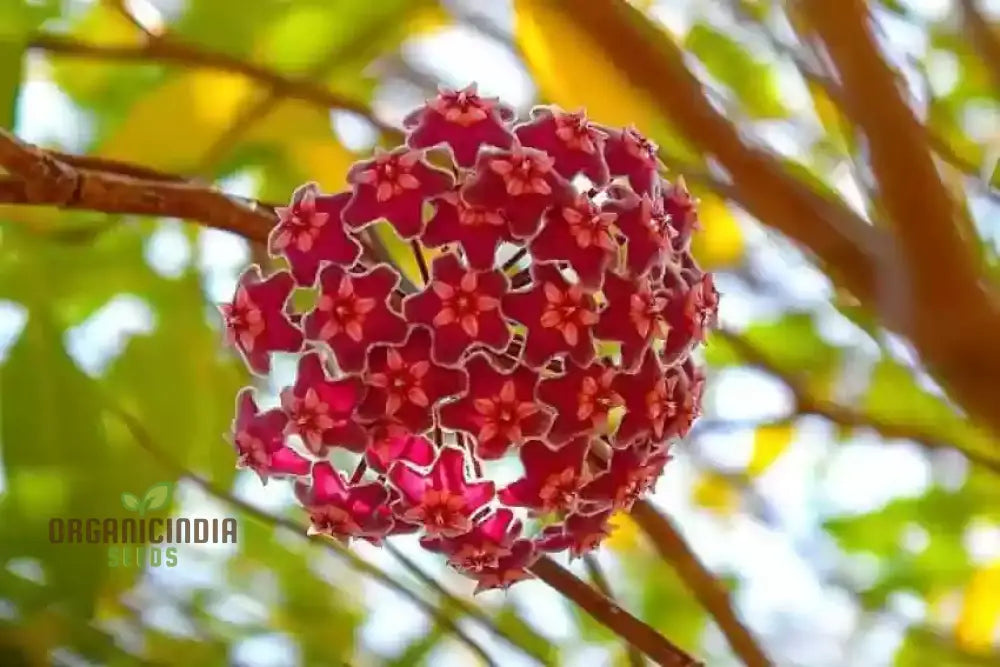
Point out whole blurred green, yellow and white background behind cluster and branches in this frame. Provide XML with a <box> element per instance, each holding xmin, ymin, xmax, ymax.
<box><xmin>0</xmin><ymin>0</ymin><xmax>1000</xmax><ymax>667</ymax></box>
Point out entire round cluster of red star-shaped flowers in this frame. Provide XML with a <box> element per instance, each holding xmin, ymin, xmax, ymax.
<box><xmin>221</xmin><ymin>86</ymin><xmax>718</xmax><ymax>590</ymax></box>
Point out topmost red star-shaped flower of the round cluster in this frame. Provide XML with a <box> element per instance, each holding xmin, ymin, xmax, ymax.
<box><xmin>403</xmin><ymin>83</ymin><xmax>514</xmax><ymax>167</ymax></box>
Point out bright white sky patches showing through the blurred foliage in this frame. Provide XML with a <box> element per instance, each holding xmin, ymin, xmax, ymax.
<box><xmin>0</xmin><ymin>0</ymin><xmax>1000</xmax><ymax>667</ymax></box>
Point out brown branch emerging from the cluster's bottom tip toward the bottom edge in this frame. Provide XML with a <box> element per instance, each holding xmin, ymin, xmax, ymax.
<box><xmin>531</xmin><ymin>556</ymin><xmax>702</xmax><ymax>667</ymax></box>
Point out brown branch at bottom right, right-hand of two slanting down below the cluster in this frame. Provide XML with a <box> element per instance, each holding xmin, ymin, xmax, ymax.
<box><xmin>632</xmin><ymin>500</ymin><xmax>774</xmax><ymax>667</ymax></box>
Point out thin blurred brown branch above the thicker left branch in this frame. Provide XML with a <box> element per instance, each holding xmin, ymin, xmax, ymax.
<box><xmin>28</xmin><ymin>34</ymin><xmax>398</xmax><ymax>134</ymax></box>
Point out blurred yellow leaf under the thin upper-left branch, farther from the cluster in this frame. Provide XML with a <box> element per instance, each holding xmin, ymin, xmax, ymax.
<box><xmin>99</xmin><ymin>71</ymin><xmax>262</xmax><ymax>171</ymax></box>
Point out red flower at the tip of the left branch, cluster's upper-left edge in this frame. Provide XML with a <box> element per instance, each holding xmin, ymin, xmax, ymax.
<box><xmin>268</xmin><ymin>183</ymin><xmax>361</xmax><ymax>286</ymax></box>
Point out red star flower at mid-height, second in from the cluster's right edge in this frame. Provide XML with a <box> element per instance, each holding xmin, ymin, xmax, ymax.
<box><xmin>594</xmin><ymin>271</ymin><xmax>670</xmax><ymax>371</ymax></box>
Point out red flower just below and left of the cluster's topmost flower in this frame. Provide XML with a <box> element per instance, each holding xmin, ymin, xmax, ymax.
<box><xmin>343</xmin><ymin>146</ymin><xmax>454</xmax><ymax>239</ymax></box>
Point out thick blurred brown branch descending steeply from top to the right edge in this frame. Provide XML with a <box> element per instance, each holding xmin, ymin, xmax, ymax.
<box><xmin>801</xmin><ymin>0</ymin><xmax>1000</xmax><ymax>444</ymax></box>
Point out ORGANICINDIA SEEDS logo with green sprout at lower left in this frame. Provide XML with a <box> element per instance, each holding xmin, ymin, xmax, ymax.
<box><xmin>49</xmin><ymin>482</ymin><xmax>238</xmax><ymax>567</ymax></box>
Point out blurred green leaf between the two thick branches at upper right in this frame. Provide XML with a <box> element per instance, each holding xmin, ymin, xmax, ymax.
<box><xmin>684</xmin><ymin>23</ymin><xmax>788</xmax><ymax>118</ymax></box>
